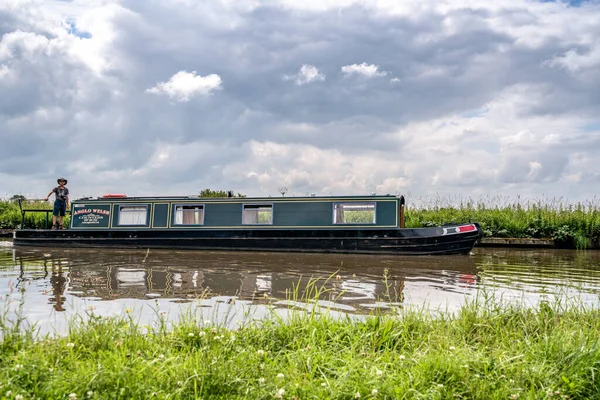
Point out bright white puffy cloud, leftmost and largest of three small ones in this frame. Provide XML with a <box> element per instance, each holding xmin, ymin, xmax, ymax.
<box><xmin>146</xmin><ymin>71</ymin><xmax>221</xmax><ymax>102</ymax></box>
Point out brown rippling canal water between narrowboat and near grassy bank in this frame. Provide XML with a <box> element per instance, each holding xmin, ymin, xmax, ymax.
<box><xmin>0</xmin><ymin>242</ymin><xmax>600</xmax><ymax>334</ymax></box>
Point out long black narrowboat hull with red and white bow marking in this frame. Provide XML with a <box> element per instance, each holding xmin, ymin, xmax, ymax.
<box><xmin>13</xmin><ymin>224</ymin><xmax>481</xmax><ymax>255</ymax></box>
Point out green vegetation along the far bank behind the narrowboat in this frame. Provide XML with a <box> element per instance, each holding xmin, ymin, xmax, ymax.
<box><xmin>0</xmin><ymin>193</ymin><xmax>600</xmax><ymax>248</ymax></box>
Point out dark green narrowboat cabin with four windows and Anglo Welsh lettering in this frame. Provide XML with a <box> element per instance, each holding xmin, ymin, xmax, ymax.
<box><xmin>70</xmin><ymin>194</ymin><xmax>404</xmax><ymax>230</ymax></box>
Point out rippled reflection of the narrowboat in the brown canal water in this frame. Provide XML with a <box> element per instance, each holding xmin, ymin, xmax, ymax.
<box><xmin>5</xmin><ymin>248</ymin><xmax>478</xmax><ymax>314</ymax></box>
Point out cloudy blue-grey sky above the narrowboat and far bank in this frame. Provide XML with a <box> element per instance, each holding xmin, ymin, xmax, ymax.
<box><xmin>0</xmin><ymin>0</ymin><xmax>600</xmax><ymax>202</ymax></box>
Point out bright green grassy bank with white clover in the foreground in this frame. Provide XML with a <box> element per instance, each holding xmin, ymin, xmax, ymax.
<box><xmin>0</xmin><ymin>299</ymin><xmax>600</xmax><ymax>399</ymax></box>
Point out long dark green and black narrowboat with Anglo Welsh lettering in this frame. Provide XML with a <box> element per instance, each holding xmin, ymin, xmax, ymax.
<box><xmin>13</xmin><ymin>194</ymin><xmax>481</xmax><ymax>255</ymax></box>
